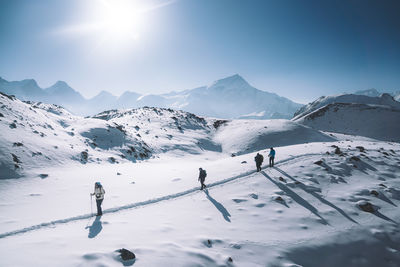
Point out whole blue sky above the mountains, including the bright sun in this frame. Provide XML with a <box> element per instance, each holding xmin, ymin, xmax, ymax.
<box><xmin>0</xmin><ymin>0</ymin><xmax>400</xmax><ymax>103</ymax></box>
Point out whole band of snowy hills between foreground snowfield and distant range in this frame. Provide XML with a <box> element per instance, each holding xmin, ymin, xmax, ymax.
<box><xmin>0</xmin><ymin>94</ymin><xmax>332</xmax><ymax>178</ymax></box>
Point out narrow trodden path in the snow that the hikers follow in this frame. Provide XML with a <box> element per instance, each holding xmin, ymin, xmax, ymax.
<box><xmin>0</xmin><ymin>153</ymin><xmax>323</xmax><ymax>238</ymax></box>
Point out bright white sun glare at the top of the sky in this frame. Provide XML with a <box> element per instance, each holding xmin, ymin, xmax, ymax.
<box><xmin>56</xmin><ymin>0</ymin><xmax>176</xmax><ymax>54</ymax></box>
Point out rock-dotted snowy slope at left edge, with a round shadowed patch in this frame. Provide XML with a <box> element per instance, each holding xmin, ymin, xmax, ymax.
<box><xmin>0</xmin><ymin>94</ymin><xmax>150</xmax><ymax>179</ymax></box>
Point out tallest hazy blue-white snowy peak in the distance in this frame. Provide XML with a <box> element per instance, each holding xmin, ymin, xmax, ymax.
<box><xmin>167</xmin><ymin>75</ymin><xmax>301</xmax><ymax>119</ymax></box>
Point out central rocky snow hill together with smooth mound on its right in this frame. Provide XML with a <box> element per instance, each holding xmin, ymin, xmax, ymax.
<box><xmin>94</xmin><ymin>108</ymin><xmax>336</xmax><ymax>158</ymax></box>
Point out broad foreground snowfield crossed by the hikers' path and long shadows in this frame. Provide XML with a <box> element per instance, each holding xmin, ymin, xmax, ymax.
<box><xmin>0</xmin><ymin>141</ymin><xmax>400</xmax><ymax>267</ymax></box>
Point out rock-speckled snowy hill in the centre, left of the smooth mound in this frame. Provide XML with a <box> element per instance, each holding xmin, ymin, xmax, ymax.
<box><xmin>93</xmin><ymin>107</ymin><xmax>221</xmax><ymax>154</ymax></box>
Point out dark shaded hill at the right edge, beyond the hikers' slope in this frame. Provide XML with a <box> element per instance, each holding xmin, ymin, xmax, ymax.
<box><xmin>292</xmin><ymin>94</ymin><xmax>400</xmax><ymax>142</ymax></box>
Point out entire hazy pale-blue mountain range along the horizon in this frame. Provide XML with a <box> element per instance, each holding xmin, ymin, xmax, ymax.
<box><xmin>0</xmin><ymin>75</ymin><xmax>302</xmax><ymax>119</ymax></box>
